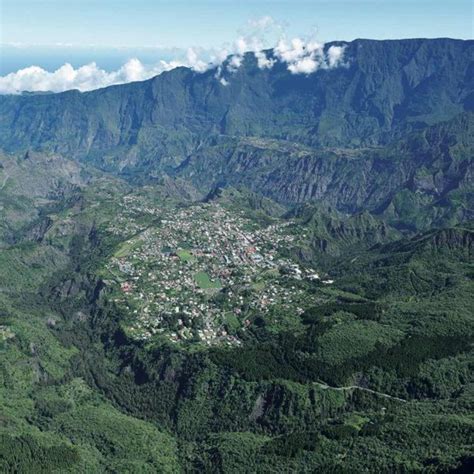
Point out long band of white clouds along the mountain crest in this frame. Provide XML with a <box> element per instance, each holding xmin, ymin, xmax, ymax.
<box><xmin>0</xmin><ymin>16</ymin><xmax>345</xmax><ymax>94</ymax></box>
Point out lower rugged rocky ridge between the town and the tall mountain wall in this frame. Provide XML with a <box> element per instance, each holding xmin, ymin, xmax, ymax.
<box><xmin>176</xmin><ymin>114</ymin><xmax>474</xmax><ymax>228</ymax></box>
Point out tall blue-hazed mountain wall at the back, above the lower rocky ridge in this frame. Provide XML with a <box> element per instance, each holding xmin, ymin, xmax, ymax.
<box><xmin>0</xmin><ymin>39</ymin><xmax>474</xmax><ymax>169</ymax></box>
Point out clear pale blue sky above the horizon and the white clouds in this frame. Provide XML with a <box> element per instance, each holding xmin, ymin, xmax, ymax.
<box><xmin>1</xmin><ymin>0</ymin><xmax>473</xmax><ymax>47</ymax></box>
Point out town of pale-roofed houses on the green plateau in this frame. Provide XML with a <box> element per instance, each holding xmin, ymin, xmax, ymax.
<box><xmin>105</xmin><ymin>197</ymin><xmax>332</xmax><ymax>345</ymax></box>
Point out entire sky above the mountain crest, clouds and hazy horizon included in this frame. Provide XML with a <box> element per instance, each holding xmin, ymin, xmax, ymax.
<box><xmin>0</xmin><ymin>0</ymin><xmax>474</xmax><ymax>93</ymax></box>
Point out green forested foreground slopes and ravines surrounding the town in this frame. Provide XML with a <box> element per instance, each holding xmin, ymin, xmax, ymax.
<box><xmin>0</xmin><ymin>168</ymin><xmax>474</xmax><ymax>472</ymax></box>
